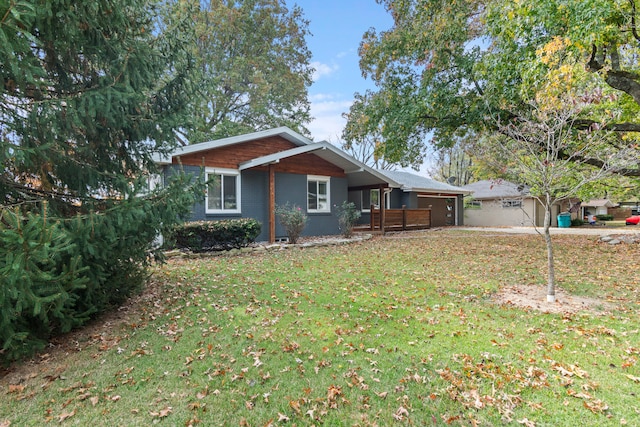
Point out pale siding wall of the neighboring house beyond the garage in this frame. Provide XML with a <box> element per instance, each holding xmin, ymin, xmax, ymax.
<box><xmin>464</xmin><ymin>198</ymin><xmax>543</xmax><ymax>227</ymax></box>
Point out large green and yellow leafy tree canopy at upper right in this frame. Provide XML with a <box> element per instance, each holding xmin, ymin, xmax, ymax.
<box><xmin>345</xmin><ymin>0</ymin><xmax>640</xmax><ymax>176</ymax></box>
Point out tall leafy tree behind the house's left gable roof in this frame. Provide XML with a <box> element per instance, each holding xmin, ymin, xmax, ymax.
<box><xmin>182</xmin><ymin>0</ymin><xmax>313</xmax><ymax>143</ymax></box>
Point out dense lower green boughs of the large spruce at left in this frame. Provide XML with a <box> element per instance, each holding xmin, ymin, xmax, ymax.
<box><xmin>0</xmin><ymin>174</ymin><xmax>195</xmax><ymax>364</ymax></box>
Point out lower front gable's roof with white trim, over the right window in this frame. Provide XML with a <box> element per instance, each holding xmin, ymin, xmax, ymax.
<box><xmin>239</xmin><ymin>141</ymin><xmax>401</xmax><ymax>187</ymax></box>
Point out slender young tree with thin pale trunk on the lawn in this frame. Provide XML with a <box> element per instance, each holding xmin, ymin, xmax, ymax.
<box><xmin>476</xmin><ymin>94</ymin><xmax>638</xmax><ymax>302</ymax></box>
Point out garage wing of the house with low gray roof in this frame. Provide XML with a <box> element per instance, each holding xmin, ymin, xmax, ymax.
<box><xmin>349</xmin><ymin>170</ymin><xmax>470</xmax><ymax>227</ymax></box>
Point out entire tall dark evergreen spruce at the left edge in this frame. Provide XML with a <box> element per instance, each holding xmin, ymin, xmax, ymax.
<box><xmin>0</xmin><ymin>0</ymin><xmax>199</xmax><ymax>359</ymax></box>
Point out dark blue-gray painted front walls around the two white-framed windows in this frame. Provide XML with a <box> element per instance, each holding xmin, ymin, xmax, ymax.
<box><xmin>164</xmin><ymin>165</ymin><xmax>347</xmax><ymax>241</ymax></box>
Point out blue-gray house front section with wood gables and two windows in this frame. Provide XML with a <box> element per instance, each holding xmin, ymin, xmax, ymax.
<box><xmin>156</xmin><ymin>127</ymin><xmax>402</xmax><ymax>241</ymax></box>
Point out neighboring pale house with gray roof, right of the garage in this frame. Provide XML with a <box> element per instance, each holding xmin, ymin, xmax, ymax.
<box><xmin>462</xmin><ymin>180</ymin><xmax>560</xmax><ymax>227</ymax></box>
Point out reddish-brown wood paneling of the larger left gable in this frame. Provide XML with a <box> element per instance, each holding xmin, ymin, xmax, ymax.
<box><xmin>172</xmin><ymin>137</ymin><xmax>297</xmax><ymax>169</ymax></box>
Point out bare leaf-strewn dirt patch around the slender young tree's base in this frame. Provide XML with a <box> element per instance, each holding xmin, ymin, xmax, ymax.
<box><xmin>494</xmin><ymin>285</ymin><xmax>615</xmax><ymax>314</ymax></box>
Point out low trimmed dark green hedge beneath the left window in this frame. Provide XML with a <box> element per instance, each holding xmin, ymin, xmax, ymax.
<box><xmin>172</xmin><ymin>218</ymin><xmax>262</xmax><ymax>252</ymax></box>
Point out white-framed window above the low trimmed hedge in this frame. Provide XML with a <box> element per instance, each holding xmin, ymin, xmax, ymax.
<box><xmin>205</xmin><ymin>169</ymin><xmax>240</xmax><ymax>213</ymax></box>
